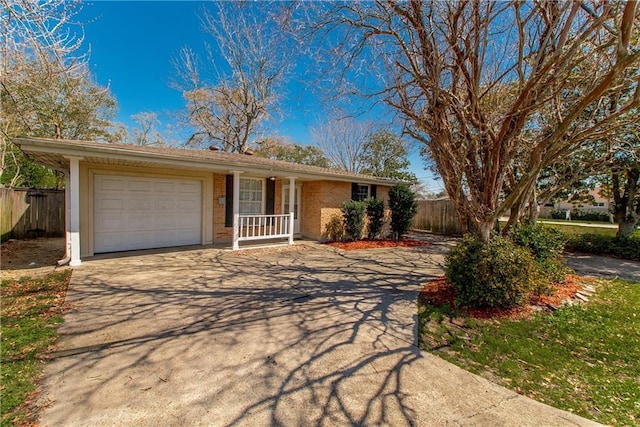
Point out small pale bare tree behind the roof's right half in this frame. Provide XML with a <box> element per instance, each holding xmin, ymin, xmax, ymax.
<box><xmin>311</xmin><ymin>114</ymin><xmax>373</xmax><ymax>173</ymax></box>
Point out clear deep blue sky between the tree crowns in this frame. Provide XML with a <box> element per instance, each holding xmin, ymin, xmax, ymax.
<box><xmin>77</xmin><ymin>1</ymin><xmax>442</xmax><ymax>190</ymax></box>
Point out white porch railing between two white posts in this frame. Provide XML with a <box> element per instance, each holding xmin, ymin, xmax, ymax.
<box><xmin>233</xmin><ymin>212</ymin><xmax>293</xmax><ymax>250</ymax></box>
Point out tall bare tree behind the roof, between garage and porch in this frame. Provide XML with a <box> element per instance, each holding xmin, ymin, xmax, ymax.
<box><xmin>176</xmin><ymin>2</ymin><xmax>290</xmax><ymax>152</ymax></box>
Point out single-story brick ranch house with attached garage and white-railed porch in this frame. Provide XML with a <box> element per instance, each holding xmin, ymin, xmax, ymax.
<box><xmin>14</xmin><ymin>138</ymin><xmax>396</xmax><ymax>265</ymax></box>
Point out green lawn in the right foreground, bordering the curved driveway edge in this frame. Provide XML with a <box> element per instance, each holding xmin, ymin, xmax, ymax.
<box><xmin>419</xmin><ymin>280</ymin><xmax>640</xmax><ymax>425</ymax></box>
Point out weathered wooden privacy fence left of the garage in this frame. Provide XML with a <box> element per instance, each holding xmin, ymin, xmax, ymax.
<box><xmin>0</xmin><ymin>188</ymin><xmax>64</xmax><ymax>242</ymax></box>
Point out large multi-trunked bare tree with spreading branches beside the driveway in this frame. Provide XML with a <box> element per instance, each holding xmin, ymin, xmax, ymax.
<box><xmin>314</xmin><ymin>0</ymin><xmax>640</xmax><ymax>241</ymax></box>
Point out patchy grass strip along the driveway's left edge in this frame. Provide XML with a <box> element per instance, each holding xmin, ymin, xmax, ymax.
<box><xmin>0</xmin><ymin>270</ymin><xmax>71</xmax><ymax>426</ymax></box>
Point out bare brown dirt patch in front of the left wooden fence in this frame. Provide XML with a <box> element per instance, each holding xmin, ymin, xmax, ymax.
<box><xmin>0</xmin><ymin>237</ymin><xmax>65</xmax><ymax>279</ymax></box>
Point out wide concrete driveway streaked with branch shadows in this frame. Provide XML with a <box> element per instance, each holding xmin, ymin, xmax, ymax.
<box><xmin>41</xmin><ymin>241</ymin><xmax>595</xmax><ymax>426</ymax></box>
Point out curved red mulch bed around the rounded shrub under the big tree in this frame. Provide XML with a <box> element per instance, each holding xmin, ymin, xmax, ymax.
<box><xmin>420</xmin><ymin>274</ymin><xmax>585</xmax><ymax>319</ymax></box>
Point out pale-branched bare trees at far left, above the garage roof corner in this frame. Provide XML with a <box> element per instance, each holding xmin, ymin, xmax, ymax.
<box><xmin>0</xmin><ymin>0</ymin><xmax>115</xmax><ymax>185</ymax></box>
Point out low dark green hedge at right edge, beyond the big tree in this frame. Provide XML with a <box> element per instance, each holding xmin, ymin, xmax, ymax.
<box><xmin>567</xmin><ymin>233</ymin><xmax>640</xmax><ymax>261</ymax></box>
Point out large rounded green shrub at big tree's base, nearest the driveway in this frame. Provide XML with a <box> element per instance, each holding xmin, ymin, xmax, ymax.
<box><xmin>445</xmin><ymin>236</ymin><xmax>538</xmax><ymax>307</ymax></box>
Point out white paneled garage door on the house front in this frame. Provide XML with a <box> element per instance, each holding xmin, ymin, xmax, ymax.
<box><xmin>93</xmin><ymin>175</ymin><xmax>202</xmax><ymax>253</ymax></box>
